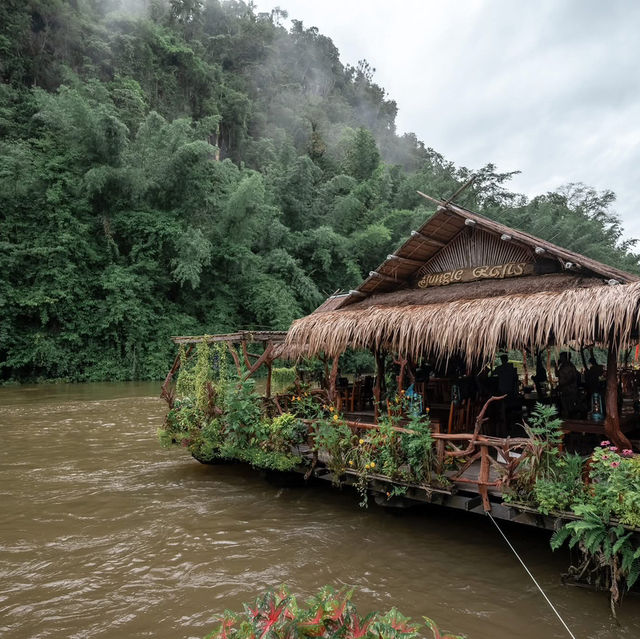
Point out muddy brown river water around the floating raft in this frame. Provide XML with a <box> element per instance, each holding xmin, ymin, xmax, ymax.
<box><xmin>0</xmin><ymin>384</ymin><xmax>640</xmax><ymax>639</ymax></box>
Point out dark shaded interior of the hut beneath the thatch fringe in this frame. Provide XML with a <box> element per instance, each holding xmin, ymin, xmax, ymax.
<box><xmin>318</xmin><ymin>346</ymin><xmax>640</xmax><ymax>452</ymax></box>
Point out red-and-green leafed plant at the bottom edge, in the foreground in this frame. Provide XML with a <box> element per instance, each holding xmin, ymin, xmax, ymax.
<box><xmin>207</xmin><ymin>586</ymin><xmax>462</xmax><ymax>639</ymax></box>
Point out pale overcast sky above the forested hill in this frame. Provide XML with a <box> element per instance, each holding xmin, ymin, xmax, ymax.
<box><xmin>255</xmin><ymin>0</ymin><xmax>640</xmax><ymax>238</ymax></box>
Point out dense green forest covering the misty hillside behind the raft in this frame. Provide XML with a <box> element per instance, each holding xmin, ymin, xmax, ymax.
<box><xmin>0</xmin><ymin>0</ymin><xmax>639</xmax><ymax>382</ymax></box>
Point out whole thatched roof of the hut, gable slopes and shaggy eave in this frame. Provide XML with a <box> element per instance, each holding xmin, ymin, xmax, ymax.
<box><xmin>285</xmin><ymin>206</ymin><xmax>640</xmax><ymax>359</ymax></box>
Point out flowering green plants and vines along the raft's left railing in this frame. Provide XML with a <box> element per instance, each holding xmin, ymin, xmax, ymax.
<box><xmin>158</xmin><ymin>339</ymin><xmax>448</xmax><ymax>506</ymax></box>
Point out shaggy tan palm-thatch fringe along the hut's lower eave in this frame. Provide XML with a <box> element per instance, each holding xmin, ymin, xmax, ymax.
<box><xmin>284</xmin><ymin>283</ymin><xmax>640</xmax><ymax>361</ymax></box>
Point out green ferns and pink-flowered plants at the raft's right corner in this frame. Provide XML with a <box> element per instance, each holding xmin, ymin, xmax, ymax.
<box><xmin>505</xmin><ymin>405</ymin><xmax>640</xmax><ymax>614</ymax></box>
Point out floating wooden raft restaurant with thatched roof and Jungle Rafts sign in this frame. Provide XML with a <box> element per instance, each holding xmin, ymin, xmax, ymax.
<box><xmin>163</xmin><ymin>202</ymin><xmax>640</xmax><ymax>527</ymax></box>
